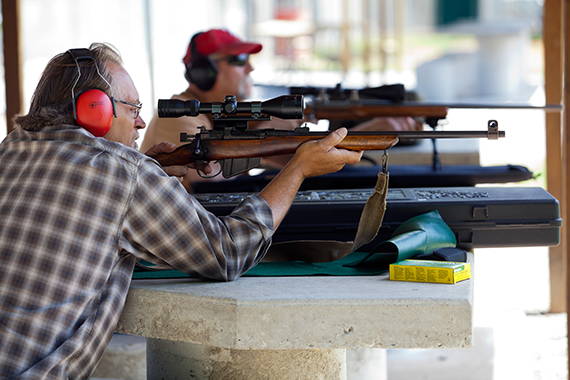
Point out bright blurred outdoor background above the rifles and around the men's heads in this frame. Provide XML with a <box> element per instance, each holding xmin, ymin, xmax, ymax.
<box><xmin>0</xmin><ymin>0</ymin><xmax>543</xmax><ymax>137</ymax></box>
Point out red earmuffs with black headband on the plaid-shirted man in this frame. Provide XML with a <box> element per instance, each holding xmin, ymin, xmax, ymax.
<box><xmin>67</xmin><ymin>49</ymin><xmax>117</xmax><ymax>137</ymax></box>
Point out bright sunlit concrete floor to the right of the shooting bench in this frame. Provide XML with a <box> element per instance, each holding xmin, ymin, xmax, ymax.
<box><xmin>387</xmin><ymin>247</ymin><xmax>568</xmax><ymax>380</ymax></box>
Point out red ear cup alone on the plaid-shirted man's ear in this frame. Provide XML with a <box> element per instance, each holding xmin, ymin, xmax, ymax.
<box><xmin>75</xmin><ymin>89</ymin><xmax>113</xmax><ymax>137</ymax></box>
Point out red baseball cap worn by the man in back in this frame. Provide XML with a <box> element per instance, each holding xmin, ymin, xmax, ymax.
<box><xmin>182</xmin><ymin>29</ymin><xmax>262</xmax><ymax>65</ymax></box>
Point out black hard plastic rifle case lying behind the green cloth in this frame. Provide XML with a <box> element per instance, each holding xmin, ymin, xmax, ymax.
<box><xmin>196</xmin><ymin>187</ymin><xmax>562</xmax><ymax>250</ymax></box>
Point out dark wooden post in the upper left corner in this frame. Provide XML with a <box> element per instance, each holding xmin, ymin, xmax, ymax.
<box><xmin>2</xmin><ymin>0</ymin><xmax>24</xmax><ymax>133</ymax></box>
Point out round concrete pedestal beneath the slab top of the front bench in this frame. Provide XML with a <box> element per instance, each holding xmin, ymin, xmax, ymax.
<box><xmin>147</xmin><ymin>338</ymin><xmax>346</xmax><ymax>380</ymax></box>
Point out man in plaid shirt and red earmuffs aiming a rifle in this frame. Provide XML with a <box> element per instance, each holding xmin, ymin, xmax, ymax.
<box><xmin>0</xmin><ymin>44</ymin><xmax>361</xmax><ymax>379</ymax></box>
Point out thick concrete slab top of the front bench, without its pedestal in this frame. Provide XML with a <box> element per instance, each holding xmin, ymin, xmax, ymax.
<box><xmin>117</xmin><ymin>256</ymin><xmax>473</xmax><ymax>349</ymax></box>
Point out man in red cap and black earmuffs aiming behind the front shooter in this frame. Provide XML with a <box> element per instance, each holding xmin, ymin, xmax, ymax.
<box><xmin>141</xmin><ymin>29</ymin><xmax>417</xmax><ymax>191</ymax></box>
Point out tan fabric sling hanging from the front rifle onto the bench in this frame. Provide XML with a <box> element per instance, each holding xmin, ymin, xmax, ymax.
<box><xmin>262</xmin><ymin>170</ymin><xmax>389</xmax><ymax>263</ymax></box>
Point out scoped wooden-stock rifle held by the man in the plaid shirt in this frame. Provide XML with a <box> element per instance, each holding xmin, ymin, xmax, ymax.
<box><xmin>152</xmin><ymin>95</ymin><xmax>505</xmax><ymax>178</ymax></box>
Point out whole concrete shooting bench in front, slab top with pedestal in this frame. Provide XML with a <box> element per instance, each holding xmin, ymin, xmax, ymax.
<box><xmin>117</xmin><ymin>255</ymin><xmax>473</xmax><ymax>380</ymax></box>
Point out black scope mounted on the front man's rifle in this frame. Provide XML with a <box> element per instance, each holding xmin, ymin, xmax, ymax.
<box><xmin>158</xmin><ymin>95</ymin><xmax>304</xmax><ymax>119</ymax></box>
